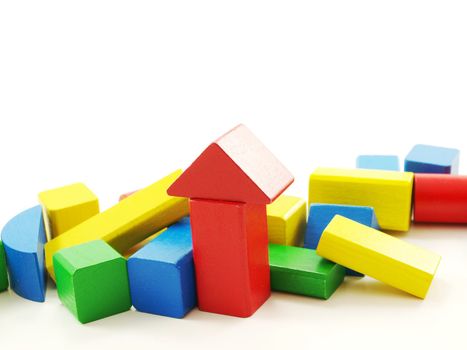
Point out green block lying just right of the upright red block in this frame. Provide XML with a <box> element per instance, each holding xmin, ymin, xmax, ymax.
<box><xmin>269</xmin><ymin>244</ymin><xmax>345</xmax><ymax>299</ymax></box>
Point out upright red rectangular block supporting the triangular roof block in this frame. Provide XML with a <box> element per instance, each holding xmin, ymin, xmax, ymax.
<box><xmin>190</xmin><ymin>199</ymin><xmax>271</xmax><ymax>317</ymax></box>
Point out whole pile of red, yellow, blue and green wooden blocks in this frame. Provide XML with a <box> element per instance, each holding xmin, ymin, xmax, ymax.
<box><xmin>0</xmin><ymin>125</ymin><xmax>460</xmax><ymax>323</ymax></box>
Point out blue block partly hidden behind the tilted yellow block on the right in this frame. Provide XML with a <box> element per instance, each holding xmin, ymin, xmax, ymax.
<box><xmin>304</xmin><ymin>204</ymin><xmax>379</xmax><ymax>277</ymax></box>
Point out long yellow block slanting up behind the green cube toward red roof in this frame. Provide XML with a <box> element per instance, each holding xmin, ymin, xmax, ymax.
<box><xmin>45</xmin><ymin>170</ymin><xmax>188</xmax><ymax>279</ymax></box>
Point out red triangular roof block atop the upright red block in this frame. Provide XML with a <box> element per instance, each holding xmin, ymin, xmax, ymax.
<box><xmin>167</xmin><ymin>125</ymin><xmax>294</xmax><ymax>204</ymax></box>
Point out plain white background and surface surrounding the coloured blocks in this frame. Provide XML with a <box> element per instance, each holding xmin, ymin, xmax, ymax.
<box><xmin>0</xmin><ymin>0</ymin><xmax>467</xmax><ymax>349</ymax></box>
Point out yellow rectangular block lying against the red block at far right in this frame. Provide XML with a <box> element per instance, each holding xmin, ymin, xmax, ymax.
<box><xmin>309</xmin><ymin>168</ymin><xmax>413</xmax><ymax>231</ymax></box>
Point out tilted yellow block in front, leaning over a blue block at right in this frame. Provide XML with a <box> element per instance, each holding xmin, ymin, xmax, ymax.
<box><xmin>316</xmin><ymin>215</ymin><xmax>441</xmax><ymax>299</ymax></box>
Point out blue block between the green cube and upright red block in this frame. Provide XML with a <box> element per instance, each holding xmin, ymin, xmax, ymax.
<box><xmin>128</xmin><ymin>218</ymin><xmax>196</xmax><ymax>318</ymax></box>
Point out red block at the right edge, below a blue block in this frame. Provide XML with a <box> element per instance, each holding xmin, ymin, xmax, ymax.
<box><xmin>414</xmin><ymin>174</ymin><xmax>467</xmax><ymax>223</ymax></box>
